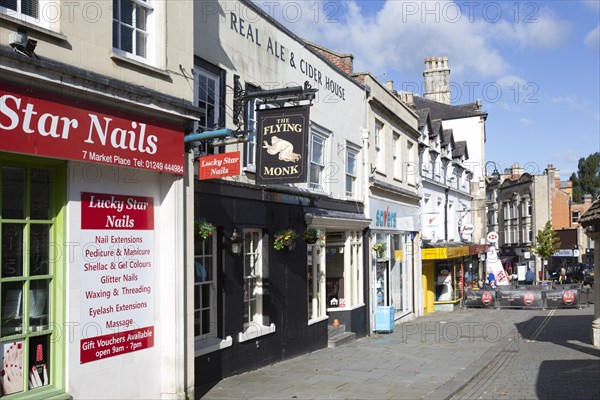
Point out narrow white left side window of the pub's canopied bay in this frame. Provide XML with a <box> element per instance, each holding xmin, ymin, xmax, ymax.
<box><xmin>306</xmin><ymin>242</ymin><xmax>328</xmax><ymax>325</ymax></box>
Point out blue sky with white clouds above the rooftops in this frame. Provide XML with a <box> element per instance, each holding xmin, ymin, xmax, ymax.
<box><xmin>255</xmin><ymin>0</ymin><xmax>600</xmax><ymax>180</ymax></box>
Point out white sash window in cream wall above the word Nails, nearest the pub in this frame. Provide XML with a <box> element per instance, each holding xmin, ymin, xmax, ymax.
<box><xmin>112</xmin><ymin>0</ymin><xmax>157</xmax><ymax>65</ymax></box>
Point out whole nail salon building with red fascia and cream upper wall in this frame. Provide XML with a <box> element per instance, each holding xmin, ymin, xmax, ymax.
<box><xmin>0</xmin><ymin>0</ymin><xmax>197</xmax><ymax>399</ymax></box>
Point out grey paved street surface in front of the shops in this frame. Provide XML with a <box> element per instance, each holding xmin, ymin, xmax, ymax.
<box><xmin>197</xmin><ymin>294</ymin><xmax>600</xmax><ymax>399</ymax></box>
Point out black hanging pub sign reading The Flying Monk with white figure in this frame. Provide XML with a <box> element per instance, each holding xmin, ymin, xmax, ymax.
<box><xmin>256</xmin><ymin>106</ymin><xmax>310</xmax><ymax>184</ymax></box>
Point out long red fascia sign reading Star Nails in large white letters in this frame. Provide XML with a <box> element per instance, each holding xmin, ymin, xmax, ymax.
<box><xmin>0</xmin><ymin>82</ymin><xmax>184</xmax><ymax>175</ymax></box>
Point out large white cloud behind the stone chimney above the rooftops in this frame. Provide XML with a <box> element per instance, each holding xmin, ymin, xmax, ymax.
<box><xmin>257</xmin><ymin>0</ymin><xmax>509</xmax><ymax>84</ymax></box>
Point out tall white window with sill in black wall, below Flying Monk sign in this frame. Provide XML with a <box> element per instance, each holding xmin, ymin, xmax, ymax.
<box><xmin>238</xmin><ymin>229</ymin><xmax>275</xmax><ymax>342</ymax></box>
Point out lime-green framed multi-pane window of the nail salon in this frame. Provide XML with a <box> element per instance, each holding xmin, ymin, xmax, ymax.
<box><xmin>0</xmin><ymin>155</ymin><xmax>64</xmax><ymax>398</ymax></box>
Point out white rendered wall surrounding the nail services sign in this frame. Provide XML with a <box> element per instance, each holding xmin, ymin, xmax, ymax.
<box><xmin>64</xmin><ymin>162</ymin><xmax>184</xmax><ymax>399</ymax></box>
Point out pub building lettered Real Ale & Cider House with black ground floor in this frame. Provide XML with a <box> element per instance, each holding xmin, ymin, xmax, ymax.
<box><xmin>188</xmin><ymin>1</ymin><xmax>370</xmax><ymax>384</ymax></box>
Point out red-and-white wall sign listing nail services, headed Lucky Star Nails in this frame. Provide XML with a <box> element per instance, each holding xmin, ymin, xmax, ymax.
<box><xmin>80</xmin><ymin>192</ymin><xmax>155</xmax><ymax>364</ymax></box>
